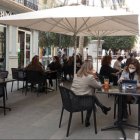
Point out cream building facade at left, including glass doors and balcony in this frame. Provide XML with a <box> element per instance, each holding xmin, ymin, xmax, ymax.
<box><xmin>0</xmin><ymin>0</ymin><xmax>38</xmax><ymax>72</ymax></box>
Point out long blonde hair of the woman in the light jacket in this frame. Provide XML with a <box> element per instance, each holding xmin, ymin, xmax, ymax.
<box><xmin>77</xmin><ymin>60</ymin><xmax>93</xmax><ymax>77</ymax></box>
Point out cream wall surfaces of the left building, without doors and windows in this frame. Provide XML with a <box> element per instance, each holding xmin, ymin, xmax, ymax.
<box><xmin>0</xmin><ymin>0</ymin><xmax>38</xmax><ymax>74</ymax></box>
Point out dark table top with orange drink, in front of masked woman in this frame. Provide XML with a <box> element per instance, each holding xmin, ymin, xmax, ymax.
<box><xmin>96</xmin><ymin>86</ymin><xmax>140</xmax><ymax>96</ymax></box>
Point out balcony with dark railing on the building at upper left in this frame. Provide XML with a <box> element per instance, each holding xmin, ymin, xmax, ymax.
<box><xmin>14</xmin><ymin>0</ymin><xmax>38</xmax><ymax>11</ymax></box>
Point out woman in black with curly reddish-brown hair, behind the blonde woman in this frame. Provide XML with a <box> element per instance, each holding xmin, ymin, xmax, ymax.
<box><xmin>100</xmin><ymin>55</ymin><xmax>121</xmax><ymax>85</ymax></box>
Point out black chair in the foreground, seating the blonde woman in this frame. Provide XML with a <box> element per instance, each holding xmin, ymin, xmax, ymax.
<box><xmin>59</xmin><ymin>86</ymin><xmax>97</xmax><ymax>137</ymax></box>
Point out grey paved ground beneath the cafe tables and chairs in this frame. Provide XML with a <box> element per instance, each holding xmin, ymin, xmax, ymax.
<box><xmin>0</xmin><ymin>80</ymin><xmax>140</xmax><ymax>140</ymax></box>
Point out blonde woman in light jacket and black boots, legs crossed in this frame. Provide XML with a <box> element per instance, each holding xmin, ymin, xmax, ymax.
<box><xmin>71</xmin><ymin>60</ymin><xmax>111</xmax><ymax>127</ymax></box>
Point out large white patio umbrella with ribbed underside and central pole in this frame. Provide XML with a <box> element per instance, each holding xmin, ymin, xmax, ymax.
<box><xmin>0</xmin><ymin>5</ymin><xmax>139</xmax><ymax>72</ymax></box>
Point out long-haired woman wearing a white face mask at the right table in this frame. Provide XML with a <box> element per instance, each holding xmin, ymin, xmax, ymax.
<box><xmin>118</xmin><ymin>60</ymin><xmax>140</xmax><ymax>121</ymax></box>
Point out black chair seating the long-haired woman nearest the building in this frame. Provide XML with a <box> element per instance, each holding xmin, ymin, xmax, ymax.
<box><xmin>25</xmin><ymin>70</ymin><xmax>47</xmax><ymax>96</ymax></box>
